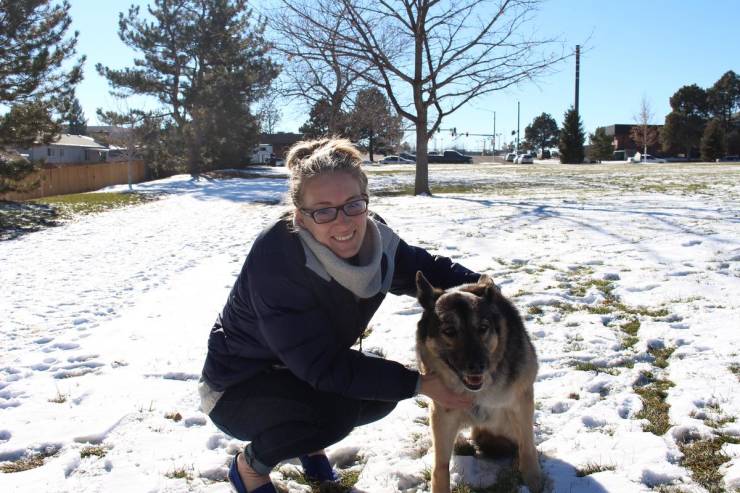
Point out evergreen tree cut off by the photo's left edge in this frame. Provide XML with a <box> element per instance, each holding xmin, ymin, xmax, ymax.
<box><xmin>0</xmin><ymin>0</ymin><xmax>85</xmax><ymax>147</ymax></box>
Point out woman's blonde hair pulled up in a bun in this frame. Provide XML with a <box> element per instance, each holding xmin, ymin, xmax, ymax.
<box><xmin>285</xmin><ymin>137</ymin><xmax>367</xmax><ymax>208</ymax></box>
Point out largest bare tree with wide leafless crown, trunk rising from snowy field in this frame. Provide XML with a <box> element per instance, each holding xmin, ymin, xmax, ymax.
<box><xmin>283</xmin><ymin>0</ymin><xmax>566</xmax><ymax>194</ymax></box>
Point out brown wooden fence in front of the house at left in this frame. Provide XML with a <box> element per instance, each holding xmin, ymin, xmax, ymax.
<box><xmin>0</xmin><ymin>160</ymin><xmax>146</xmax><ymax>201</ymax></box>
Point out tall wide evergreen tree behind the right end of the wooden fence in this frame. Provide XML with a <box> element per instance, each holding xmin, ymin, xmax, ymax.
<box><xmin>96</xmin><ymin>0</ymin><xmax>278</xmax><ymax>174</ymax></box>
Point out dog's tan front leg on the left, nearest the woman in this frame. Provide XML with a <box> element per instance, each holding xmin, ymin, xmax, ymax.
<box><xmin>431</xmin><ymin>402</ymin><xmax>460</xmax><ymax>493</ymax></box>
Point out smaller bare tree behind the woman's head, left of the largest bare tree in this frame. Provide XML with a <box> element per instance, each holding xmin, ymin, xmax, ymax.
<box><xmin>269</xmin><ymin>4</ymin><xmax>367</xmax><ymax>133</ymax></box>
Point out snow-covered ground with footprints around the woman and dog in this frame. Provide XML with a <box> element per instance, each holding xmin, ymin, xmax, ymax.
<box><xmin>0</xmin><ymin>164</ymin><xmax>740</xmax><ymax>493</ymax></box>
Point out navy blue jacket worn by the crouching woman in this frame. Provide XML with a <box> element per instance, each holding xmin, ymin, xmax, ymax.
<box><xmin>203</xmin><ymin>219</ymin><xmax>479</xmax><ymax>401</ymax></box>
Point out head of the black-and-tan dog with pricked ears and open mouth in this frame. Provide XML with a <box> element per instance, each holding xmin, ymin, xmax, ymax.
<box><xmin>416</xmin><ymin>272</ymin><xmax>505</xmax><ymax>391</ymax></box>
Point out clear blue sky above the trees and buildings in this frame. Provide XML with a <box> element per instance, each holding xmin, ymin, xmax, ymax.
<box><xmin>71</xmin><ymin>0</ymin><xmax>740</xmax><ymax>149</ymax></box>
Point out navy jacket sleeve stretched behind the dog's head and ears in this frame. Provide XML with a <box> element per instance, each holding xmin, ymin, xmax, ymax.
<box><xmin>390</xmin><ymin>235</ymin><xmax>480</xmax><ymax>296</ymax></box>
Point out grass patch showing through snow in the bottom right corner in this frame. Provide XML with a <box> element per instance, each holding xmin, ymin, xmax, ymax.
<box><xmin>678</xmin><ymin>435</ymin><xmax>737</xmax><ymax>493</ymax></box>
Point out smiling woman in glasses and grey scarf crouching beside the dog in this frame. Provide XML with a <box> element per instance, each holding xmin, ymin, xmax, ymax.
<box><xmin>200</xmin><ymin>139</ymin><xmax>479</xmax><ymax>493</ymax></box>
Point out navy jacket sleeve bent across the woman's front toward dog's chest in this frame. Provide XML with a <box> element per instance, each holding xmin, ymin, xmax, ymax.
<box><xmin>241</xmin><ymin>250</ymin><xmax>418</xmax><ymax>401</ymax></box>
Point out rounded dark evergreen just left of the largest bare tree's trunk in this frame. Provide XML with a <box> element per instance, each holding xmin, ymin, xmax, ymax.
<box><xmin>348</xmin><ymin>87</ymin><xmax>403</xmax><ymax>161</ymax></box>
